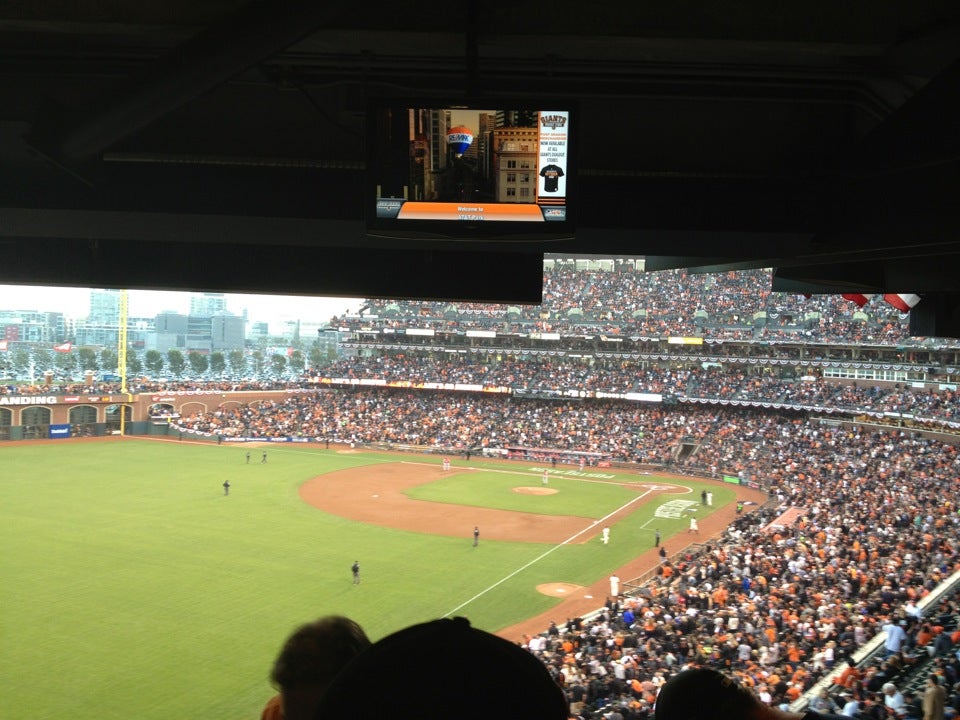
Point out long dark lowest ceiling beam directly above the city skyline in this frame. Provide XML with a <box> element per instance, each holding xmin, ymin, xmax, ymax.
<box><xmin>0</xmin><ymin>237</ymin><xmax>543</xmax><ymax>305</ymax></box>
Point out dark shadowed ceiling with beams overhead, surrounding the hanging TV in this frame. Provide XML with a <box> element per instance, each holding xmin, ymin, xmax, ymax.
<box><xmin>0</xmin><ymin>0</ymin><xmax>960</xmax><ymax>305</ymax></box>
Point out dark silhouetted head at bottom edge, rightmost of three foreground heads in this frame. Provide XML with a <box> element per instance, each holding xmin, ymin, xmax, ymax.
<box><xmin>654</xmin><ymin>668</ymin><xmax>843</xmax><ymax>720</ymax></box>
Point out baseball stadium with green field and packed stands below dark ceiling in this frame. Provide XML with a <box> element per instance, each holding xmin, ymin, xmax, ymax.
<box><xmin>0</xmin><ymin>257</ymin><xmax>960</xmax><ymax>720</ymax></box>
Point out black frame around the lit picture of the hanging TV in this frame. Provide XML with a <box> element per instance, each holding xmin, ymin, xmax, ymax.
<box><xmin>363</xmin><ymin>97</ymin><xmax>580</xmax><ymax>243</ymax></box>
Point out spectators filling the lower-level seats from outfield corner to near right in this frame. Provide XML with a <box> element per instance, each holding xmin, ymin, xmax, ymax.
<box><xmin>172</xmin><ymin>390</ymin><xmax>960</xmax><ymax>720</ymax></box>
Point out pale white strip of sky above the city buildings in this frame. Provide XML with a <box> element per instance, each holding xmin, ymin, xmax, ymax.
<box><xmin>0</xmin><ymin>285</ymin><xmax>362</xmax><ymax>322</ymax></box>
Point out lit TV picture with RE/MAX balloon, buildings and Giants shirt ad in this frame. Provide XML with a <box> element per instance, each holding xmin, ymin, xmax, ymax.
<box><xmin>375</xmin><ymin>107</ymin><xmax>569</xmax><ymax>223</ymax></box>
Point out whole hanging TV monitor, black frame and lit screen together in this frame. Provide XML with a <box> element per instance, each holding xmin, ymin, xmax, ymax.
<box><xmin>366</xmin><ymin>101</ymin><xmax>577</xmax><ymax>241</ymax></box>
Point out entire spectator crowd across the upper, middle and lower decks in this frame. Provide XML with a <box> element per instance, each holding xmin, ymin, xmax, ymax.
<box><xmin>0</xmin><ymin>263</ymin><xmax>960</xmax><ymax>720</ymax></box>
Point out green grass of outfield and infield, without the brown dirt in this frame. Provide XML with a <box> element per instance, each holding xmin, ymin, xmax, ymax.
<box><xmin>0</xmin><ymin>440</ymin><xmax>733</xmax><ymax>720</ymax></box>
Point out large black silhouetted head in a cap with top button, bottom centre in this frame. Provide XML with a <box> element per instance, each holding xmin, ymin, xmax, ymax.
<box><xmin>314</xmin><ymin>618</ymin><xmax>568</xmax><ymax>720</ymax></box>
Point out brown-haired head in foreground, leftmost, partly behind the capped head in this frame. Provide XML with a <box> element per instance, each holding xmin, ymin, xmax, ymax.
<box><xmin>263</xmin><ymin>615</ymin><xmax>370</xmax><ymax>720</ymax></box>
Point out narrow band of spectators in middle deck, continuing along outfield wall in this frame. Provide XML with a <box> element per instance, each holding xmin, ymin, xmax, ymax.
<box><xmin>0</xmin><ymin>354</ymin><xmax>960</xmax><ymax>434</ymax></box>
